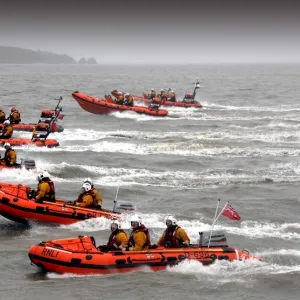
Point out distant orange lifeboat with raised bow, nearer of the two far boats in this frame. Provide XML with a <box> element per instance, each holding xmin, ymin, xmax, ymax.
<box><xmin>72</xmin><ymin>91</ymin><xmax>168</xmax><ymax>117</ymax></box>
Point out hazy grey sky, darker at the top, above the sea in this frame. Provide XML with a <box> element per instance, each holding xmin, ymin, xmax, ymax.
<box><xmin>0</xmin><ymin>0</ymin><xmax>300</xmax><ymax>63</ymax></box>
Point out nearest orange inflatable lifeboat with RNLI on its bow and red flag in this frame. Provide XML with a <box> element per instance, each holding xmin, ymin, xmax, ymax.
<box><xmin>28</xmin><ymin>232</ymin><xmax>259</xmax><ymax>275</ymax></box>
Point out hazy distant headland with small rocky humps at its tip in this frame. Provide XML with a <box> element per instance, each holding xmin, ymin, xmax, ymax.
<box><xmin>0</xmin><ymin>46</ymin><xmax>97</xmax><ymax>65</ymax></box>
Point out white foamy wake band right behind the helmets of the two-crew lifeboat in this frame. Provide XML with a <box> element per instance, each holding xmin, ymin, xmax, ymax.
<box><xmin>4</xmin><ymin>160</ymin><xmax>300</xmax><ymax>189</ymax></box>
